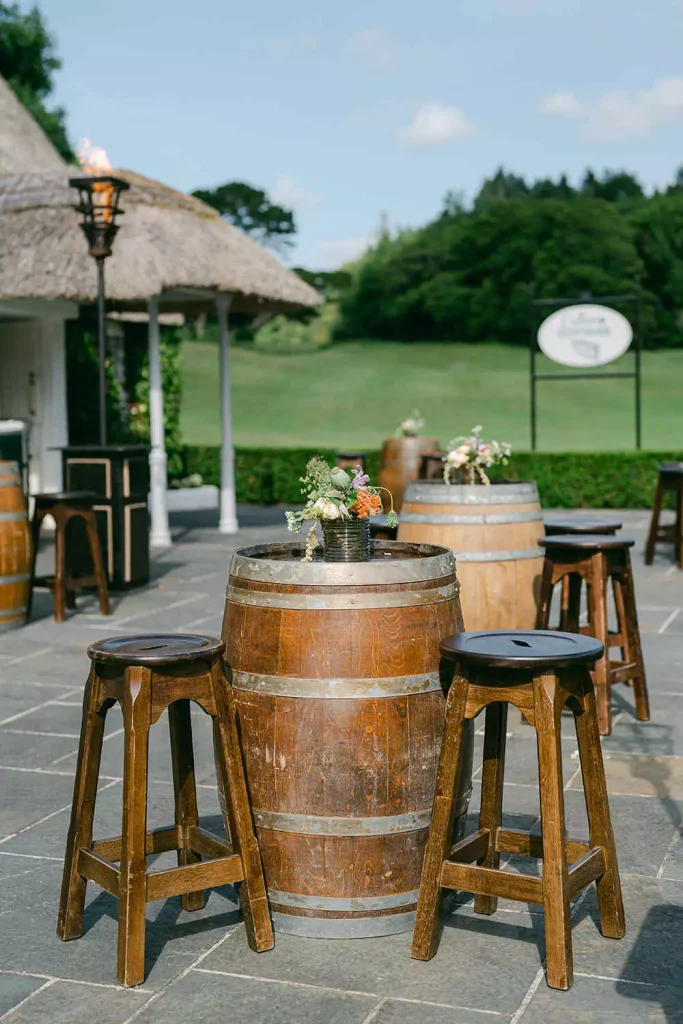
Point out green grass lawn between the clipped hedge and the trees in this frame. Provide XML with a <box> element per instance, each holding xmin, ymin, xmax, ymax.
<box><xmin>181</xmin><ymin>341</ymin><xmax>683</xmax><ymax>451</ymax></box>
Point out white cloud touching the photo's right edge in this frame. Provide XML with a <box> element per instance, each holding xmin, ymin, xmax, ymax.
<box><xmin>589</xmin><ymin>78</ymin><xmax>683</xmax><ymax>139</ymax></box>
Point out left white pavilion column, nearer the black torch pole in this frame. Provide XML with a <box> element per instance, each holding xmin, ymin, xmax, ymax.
<box><xmin>147</xmin><ymin>295</ymin><xmax>171</xmax><ymax>548</ymax></box>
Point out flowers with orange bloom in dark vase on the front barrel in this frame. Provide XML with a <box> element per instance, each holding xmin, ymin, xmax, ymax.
<box><xmin>285</xmin><ymin>456</ymin><xmax>398</xmax><ymax>562</ymax></box>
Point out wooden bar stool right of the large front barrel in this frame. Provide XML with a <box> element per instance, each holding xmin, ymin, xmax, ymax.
<box><xmin>412</xmin><ymin>630</ymin><xmax>626</xmax><ymax>988</ymax></box>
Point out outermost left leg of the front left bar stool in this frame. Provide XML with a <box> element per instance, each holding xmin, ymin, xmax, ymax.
<box><xmin>57</xmin><ymin>668</ymin><xmax>105</xmax><ymax>942</ymax></box>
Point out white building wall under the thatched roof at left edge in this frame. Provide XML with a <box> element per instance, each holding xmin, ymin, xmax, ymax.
<box><xmin>0</xmin><ymin>318</ymin><xmax>68</xmax><ymax>494</ymax></box>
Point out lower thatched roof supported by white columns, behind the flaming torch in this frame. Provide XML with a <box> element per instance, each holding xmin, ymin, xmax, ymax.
<box><xmin>0</xmin><ymin>170</ymin><xmax>321</xmax><ymax>312</ymax></box>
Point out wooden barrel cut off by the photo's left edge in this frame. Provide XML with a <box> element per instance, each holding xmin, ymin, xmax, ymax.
<box><xmin>0</xmin><ymin>462</ymin><xmax>31</xmax><ymax>632</ymax></box>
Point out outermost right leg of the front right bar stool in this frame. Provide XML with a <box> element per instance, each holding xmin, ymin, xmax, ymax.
<box><xmin>574</xmin><ymin>672</ymin><xmax>626</xmax><ymax>939</ymax></box>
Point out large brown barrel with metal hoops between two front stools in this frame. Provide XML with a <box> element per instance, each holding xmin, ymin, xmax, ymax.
<box><xmin>223</xmin><ymin>541</ymin><xmax>472</xmax><ymax>938</ymax></box>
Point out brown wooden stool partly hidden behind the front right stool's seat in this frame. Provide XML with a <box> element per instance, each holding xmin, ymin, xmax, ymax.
<box><xmin>537</xmin><ymin>534</ymin><xmax>650</xmax><ymax>736</ymax></box>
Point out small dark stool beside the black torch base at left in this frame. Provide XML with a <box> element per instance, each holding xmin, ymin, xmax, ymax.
<box><xmin>29</xmin><ymin>490</ymin><xmax>111</xmax><ymax>623</ymax></box>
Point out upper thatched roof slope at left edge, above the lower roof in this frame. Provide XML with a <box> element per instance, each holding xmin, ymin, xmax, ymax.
<box><xmin>0</xmin><ymin>77</ymin><xmax>66</xmax><ymax>174</ymax></box>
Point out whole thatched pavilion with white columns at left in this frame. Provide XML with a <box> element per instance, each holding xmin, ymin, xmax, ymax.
<box><xmin>0</xmin><ymin>79</ymin><xmax>319</xmax><ymax>546</ymax></box>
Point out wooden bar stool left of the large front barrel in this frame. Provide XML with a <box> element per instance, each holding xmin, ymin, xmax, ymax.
<box><xmin>57</xmin><ymin>634</ymin><xmax>273</xmax><ymax>985</ymax></box>
